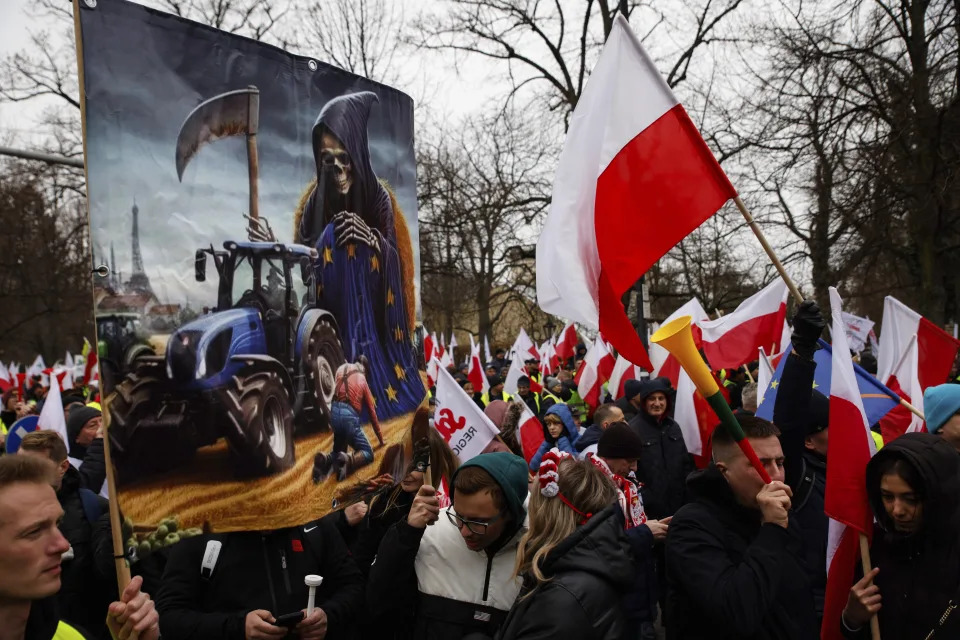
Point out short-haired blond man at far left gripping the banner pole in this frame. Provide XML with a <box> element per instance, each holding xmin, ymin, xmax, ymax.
<box><xmin>0</xmin><ymin>455</ymin><xmax>160</xmax><ymax>640</ymax></box>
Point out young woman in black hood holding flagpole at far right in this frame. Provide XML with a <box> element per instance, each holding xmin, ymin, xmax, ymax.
<box><xmin>841</xmin><ymin>433</ymin><xmax>960</xmax><ymax>640</ymax></box>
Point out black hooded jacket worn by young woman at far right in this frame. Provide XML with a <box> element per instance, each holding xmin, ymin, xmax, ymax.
<box><xmin>852</xmin><ymin>433</ymin><xmax>960</xmax><ymax>640</ymax></box>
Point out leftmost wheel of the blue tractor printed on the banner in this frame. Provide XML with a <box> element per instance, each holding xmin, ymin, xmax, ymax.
<box><xmin>106</xmin><ymin>373</ymin><xmax>196</xmax><ymax>482</ymax></box>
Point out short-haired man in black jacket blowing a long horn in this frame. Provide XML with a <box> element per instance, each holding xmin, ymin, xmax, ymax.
<box><xmin>666</xmin><ymin>417</ymin><xmax>820</xmax><ymax>640</ymax></box>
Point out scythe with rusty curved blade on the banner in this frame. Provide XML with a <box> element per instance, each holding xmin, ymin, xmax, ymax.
<box><xmin>177</xmin><ymin>86</ymin><xmax>260</xmax><ymax>228</ymax></box>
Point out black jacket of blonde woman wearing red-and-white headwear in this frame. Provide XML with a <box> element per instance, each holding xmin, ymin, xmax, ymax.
<box><xmin>497</xmin><ymin>504</ymin><xmax>636</xmax><ymax>640</ymax></box>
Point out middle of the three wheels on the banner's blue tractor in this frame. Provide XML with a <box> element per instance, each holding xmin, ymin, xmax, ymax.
<box><xmin>227</xmin><ymin>371</ymin><xmax>294</xmax><ymax>476</ymax></box>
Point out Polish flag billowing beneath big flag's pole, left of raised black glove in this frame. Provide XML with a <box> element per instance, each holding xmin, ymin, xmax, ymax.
<box><xmin>700</xmin><ymin>278</ymin><xmax>789</xmax><ymax>371</ymax></box>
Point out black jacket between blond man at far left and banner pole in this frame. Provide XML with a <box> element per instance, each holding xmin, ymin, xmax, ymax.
<box><xmin>57</xmin><ymin>467</ymin><xmax>117</xmax><ymax>639</ymax></box>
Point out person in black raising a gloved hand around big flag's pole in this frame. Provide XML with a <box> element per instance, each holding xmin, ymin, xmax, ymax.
<box><xmin>773</xmin><ymin>300</ymin><xmax>830</xmax><ymax>617</ymax></box>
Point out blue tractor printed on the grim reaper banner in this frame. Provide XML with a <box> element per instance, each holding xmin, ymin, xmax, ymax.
<box><xmin>107</xmin><ymin>241</ymin><xmax>344</xmax><ymax>482</ymax></box>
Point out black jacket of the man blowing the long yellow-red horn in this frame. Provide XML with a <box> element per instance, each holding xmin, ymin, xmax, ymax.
<box><xmin>666</xmin><ymin>465</ymin><xmax>820</xmax><ymax>640</ymax></box>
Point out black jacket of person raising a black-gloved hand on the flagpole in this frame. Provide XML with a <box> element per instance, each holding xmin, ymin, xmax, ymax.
<box><xmin>773</xmin><ymin>353</ymin><xmax>829</xmax><ymax>616</ymax></box>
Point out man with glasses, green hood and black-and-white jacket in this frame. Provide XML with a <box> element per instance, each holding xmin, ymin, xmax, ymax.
<box><xmin>367</xmin><ymin>452</ymin><xmax>527</xmax><ymax>640</ymax></box>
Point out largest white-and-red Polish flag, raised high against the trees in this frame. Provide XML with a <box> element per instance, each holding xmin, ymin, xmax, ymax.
<box><xmin>536</xmin><ymin>15</ymin><xmax>737</xmax><ymax>371</ymax></box>
